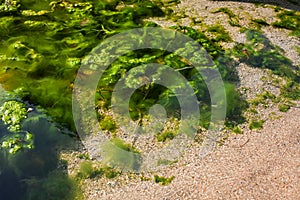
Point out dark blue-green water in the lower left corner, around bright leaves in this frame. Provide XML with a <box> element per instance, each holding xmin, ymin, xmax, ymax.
<box><xmin>0</xmin><ymin>90</ymin><xmax>72</xmax><ymax>200</ymax></box>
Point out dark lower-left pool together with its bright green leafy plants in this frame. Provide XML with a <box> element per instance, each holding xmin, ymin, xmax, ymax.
<box><xmin>0</xmin><ymin>100</ymin><xmax>76</xmax><ymax>200</ymax></box>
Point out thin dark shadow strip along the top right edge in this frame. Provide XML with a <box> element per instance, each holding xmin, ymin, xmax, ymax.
<box><xmin>213</xmin><ymin>0</ymin><xmax>300</xmax><ymax>11</ymax></box>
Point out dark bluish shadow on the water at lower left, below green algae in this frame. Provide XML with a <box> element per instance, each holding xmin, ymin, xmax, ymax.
<box><xmin>0</xmin><ymin>105</ymin><xmax>79</xmax><ymax>200</ymax></box>
